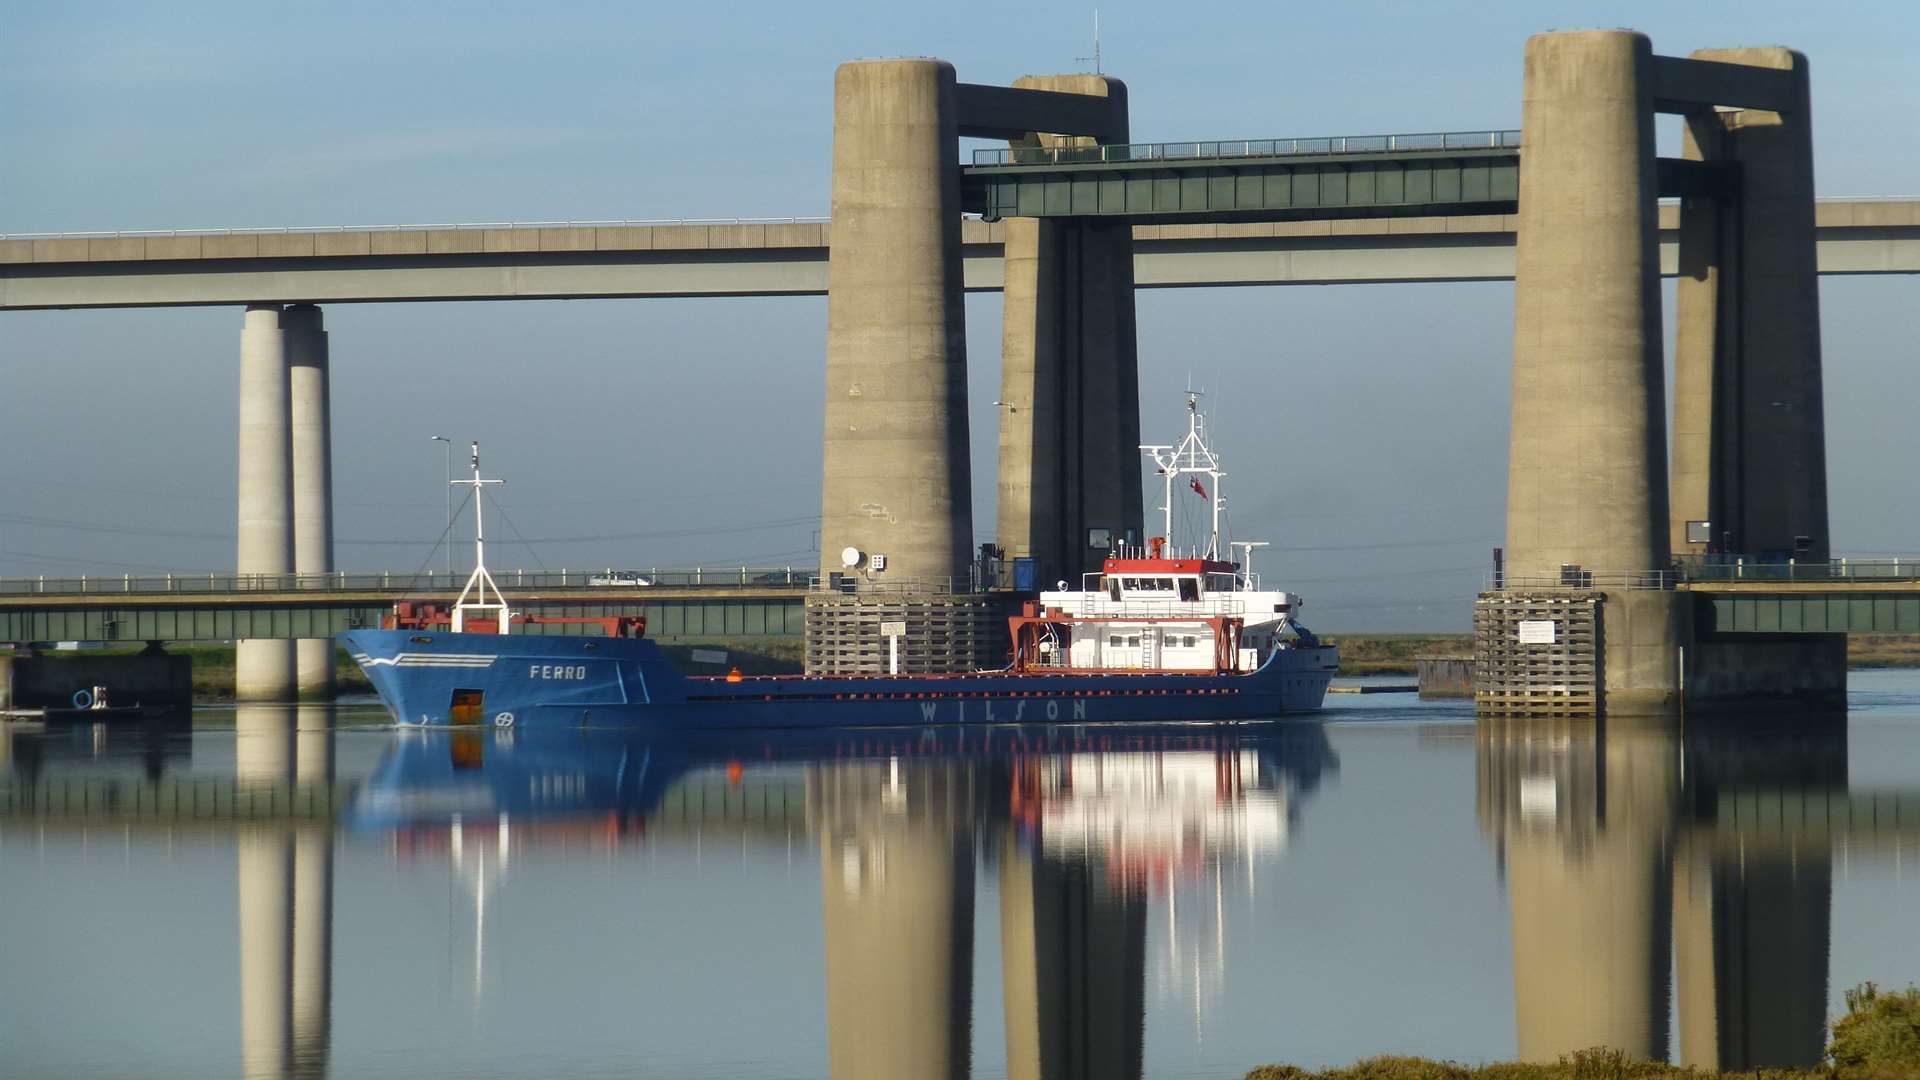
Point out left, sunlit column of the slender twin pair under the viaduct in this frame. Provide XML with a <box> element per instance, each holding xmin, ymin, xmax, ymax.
<box><xmin>234</xmin><ymin>304</ymin><xmax>294</xmax><ymax>701</ymax></box>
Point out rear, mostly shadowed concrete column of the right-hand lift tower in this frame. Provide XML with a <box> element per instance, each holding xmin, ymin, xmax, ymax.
<box><xmin>1670</xmin><ymin>48</ymin><xmax>1830</xmax><ymax>561</ymax></box>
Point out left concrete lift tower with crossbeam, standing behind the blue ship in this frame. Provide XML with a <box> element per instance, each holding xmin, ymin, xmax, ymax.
<box><xmin>806</xmin><ymin>60</ymin><xmax>1140</xmax><ymax>673</ymax></box>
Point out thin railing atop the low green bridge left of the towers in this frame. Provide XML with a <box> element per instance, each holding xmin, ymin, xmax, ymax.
<box><xmin>0</xmin><ymin>565</ymin><xmax>816</xmax><ymax>596</ymax></box>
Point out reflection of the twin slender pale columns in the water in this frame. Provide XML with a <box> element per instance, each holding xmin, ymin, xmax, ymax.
<box><xmin>234</xmin><ymin>705</ymin><xmax>334</xmax><ymax>1080</ymax></box>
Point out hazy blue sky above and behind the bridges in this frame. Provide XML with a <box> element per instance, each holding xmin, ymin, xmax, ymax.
<box><xmin>0</xmin><ymin>0</ymin><xmax>1920</xmax><ymax>632</ymax></box>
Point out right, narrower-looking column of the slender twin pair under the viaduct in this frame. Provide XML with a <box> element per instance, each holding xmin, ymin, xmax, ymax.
<box><xmin>280</xmin><ymin>304</ymin><xmax>334</xmax><ymax>698</ymax></box>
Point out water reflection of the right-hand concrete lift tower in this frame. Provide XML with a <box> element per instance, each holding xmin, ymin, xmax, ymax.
<box><xmin>1478</xmin><ymin>717</ymin><xmax>1847</xmax><ymax>1070</ymax></box>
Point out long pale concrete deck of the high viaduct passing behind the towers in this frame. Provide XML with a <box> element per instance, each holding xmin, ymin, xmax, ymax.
<box><xmin>0</xmin><ymin>198</ymin><xmax>1920</xmax><ymax>311</ymax></box>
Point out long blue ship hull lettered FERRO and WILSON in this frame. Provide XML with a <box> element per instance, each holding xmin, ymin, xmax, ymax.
<box><xmin>340</xmin><ymin>630</ymin><xmax>1338</xmax><ymax>730</ymax></box>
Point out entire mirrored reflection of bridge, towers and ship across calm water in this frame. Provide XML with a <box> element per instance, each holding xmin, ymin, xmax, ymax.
<box><xmin>0</xmin><ymin>705</ymin><xmax>1920</xmax><ymax>1080</ymax></box>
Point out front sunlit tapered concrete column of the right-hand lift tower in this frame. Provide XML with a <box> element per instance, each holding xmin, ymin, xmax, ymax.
<box><xmin>1507</xmin><ymin>31</ymin><xmax>1686</xmax><ymax>711</ymax></box>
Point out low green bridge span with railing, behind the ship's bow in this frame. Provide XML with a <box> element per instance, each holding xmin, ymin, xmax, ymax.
<box><xmin>0</xmin><ymin>567</ymin><xmax>808</xmax><ymax>642</ymax></box>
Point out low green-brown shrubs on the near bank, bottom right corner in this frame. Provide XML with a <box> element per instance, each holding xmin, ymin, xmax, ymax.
<box><xmin>1246</xmin><ymin>982</ymin><xmax>1920</xmax><ymax>1080</ymax></box>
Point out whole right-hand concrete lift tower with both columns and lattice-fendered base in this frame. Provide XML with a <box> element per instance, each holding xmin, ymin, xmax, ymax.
<box><xmin>1476</xmin><ymin>31</ymin><xmax>1845</xmax><ymax>713</ymax></box>
